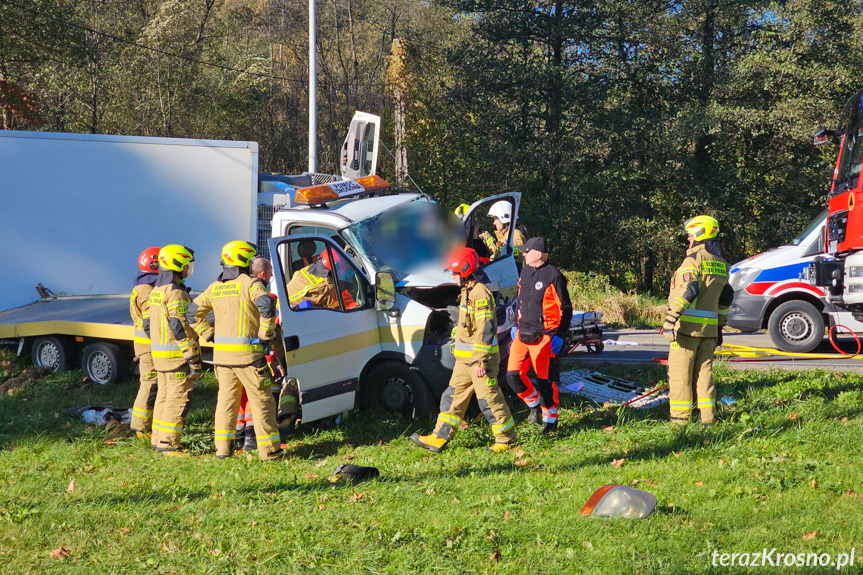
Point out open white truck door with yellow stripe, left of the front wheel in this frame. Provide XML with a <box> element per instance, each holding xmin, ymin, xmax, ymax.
<box><xmin>269</xmin><ymin>234</ymin><xmax>381</xmax><ymax>421</ymax></box>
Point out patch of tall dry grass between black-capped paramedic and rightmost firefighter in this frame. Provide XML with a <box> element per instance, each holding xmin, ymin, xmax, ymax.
<box><xmin>563</xmin><ymin>272</ymin><xmax>667</xmax><ymax>329</ymax></box>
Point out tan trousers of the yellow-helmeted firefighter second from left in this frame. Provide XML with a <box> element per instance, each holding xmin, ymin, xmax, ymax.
<box><xmin>150</xmin><ymin>366</ymin><xmax>195</xmax><ymax>451</ymax></box>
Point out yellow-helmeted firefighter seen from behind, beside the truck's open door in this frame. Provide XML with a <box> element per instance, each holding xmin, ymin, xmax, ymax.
<box><xmin>187</xmin><ymin>241</ymin><xmax>282</xmax><ymax>460</ymax></box>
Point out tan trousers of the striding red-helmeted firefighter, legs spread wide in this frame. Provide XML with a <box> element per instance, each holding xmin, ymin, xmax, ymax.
<box><xmin>433</xmin><ymin>361</ymin><xmax>515</xmax><ymax>443</ymax></box>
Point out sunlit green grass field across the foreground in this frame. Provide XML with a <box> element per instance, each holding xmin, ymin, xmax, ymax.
<box><xmin>0</xmin><ymin>348</ymin><xmax>863</xmax><ymax>574</ymax></box>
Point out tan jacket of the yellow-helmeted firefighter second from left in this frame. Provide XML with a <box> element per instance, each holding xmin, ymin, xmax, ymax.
<box><xmin>149</xmin><ymin>276</ymin><xmax>201</xmax><ymax>372</ymax></box>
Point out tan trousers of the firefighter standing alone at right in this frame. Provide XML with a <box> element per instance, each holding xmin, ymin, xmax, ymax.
<box><xmin>668</xmin><ymin>334</ymin><xmax>716</xmax><ymax>423</ymax></box>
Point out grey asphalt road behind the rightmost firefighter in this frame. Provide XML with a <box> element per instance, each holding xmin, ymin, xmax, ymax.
<box><xmin>563</xmin><ymin>330</ymin><xmax>863</xmax><ymax>373</ymax></box>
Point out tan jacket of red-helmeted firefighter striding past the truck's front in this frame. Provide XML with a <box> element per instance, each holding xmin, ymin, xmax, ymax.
<box><xmin>453</xmin><ymin>279</ymin><xmax>499</xmax><ymax>368</ymax></box>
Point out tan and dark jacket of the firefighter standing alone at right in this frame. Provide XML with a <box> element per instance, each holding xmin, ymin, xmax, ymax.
<box><xmin>663</xmin><ymin>244</ymin><xmax>734</xmax><ymax>337</ymax></box>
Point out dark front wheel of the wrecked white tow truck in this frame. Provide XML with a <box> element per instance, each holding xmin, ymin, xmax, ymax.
<box><xmin>363</xmin><ymin>361</ymin><xmax>434</xmax><ymax>419</ymax></box>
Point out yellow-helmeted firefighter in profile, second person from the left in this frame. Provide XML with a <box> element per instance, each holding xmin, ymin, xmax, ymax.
<box><xmin>149</xmin><ymin>244</ymin><xmax>202</xmax><ymax>456</ymax></box>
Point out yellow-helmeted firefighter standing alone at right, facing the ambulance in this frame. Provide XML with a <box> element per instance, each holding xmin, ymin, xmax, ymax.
<box><xmin>662</xmin><ymin>216</ymin><xmax>734</xmax><ymax>425</ymax></box>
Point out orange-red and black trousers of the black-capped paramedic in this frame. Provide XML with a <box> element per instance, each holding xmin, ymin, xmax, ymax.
<box><xmin>506</xmin><ymin>334</ymin><xmax>560</xmax><ymax>423</ymax></box>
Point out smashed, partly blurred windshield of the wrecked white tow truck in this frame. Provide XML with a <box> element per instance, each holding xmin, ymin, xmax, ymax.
<box><xmin>341</xmin><ymin>197</ymin><xmax>465</xmax><ymax>282</ymax></box>
